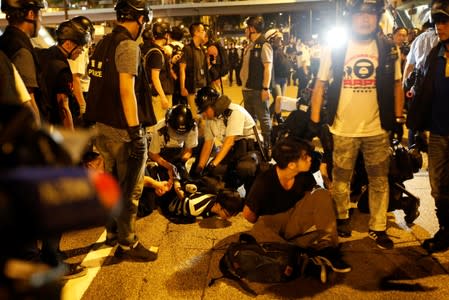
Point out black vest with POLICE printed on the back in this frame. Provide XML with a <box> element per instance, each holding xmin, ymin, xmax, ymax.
<box><xmin>85</xmin><ymin>26</ymin><xmax>156</xmax><ymax>129</ymax></box>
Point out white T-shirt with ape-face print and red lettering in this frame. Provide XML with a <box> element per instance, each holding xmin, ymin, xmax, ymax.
<box><xmin>317</xmin><ymin>40</ymin><xmax>402</xmax><ymax>137</ymax></box>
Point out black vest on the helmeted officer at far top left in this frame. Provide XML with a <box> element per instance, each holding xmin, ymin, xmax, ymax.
<box><xmin>0</xmin><ymin>26</ymin><xmax>51</xmax><ymax>121</ymax></box>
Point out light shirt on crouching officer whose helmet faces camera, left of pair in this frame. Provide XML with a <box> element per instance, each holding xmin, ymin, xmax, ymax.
<box><xmin>149</xmin><ymin>119</ymin><xmax>198</xmax><ymax>154</ymax></box>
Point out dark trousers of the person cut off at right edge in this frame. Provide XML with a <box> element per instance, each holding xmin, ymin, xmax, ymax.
<box><xmin>429</xmin><ymin>133</ymin><xmax>449</xmax><ymax>229</ymax></box>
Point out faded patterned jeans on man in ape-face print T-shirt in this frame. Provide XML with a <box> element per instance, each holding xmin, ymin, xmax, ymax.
<box><xmin>332</xmin><ymin>133</ymin><xmax>390</xmax><ymax>231</ymax></box>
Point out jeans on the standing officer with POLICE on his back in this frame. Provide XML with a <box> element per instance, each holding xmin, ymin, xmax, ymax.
<box><xmin>96</xmin><ymin>126</ymin><xmax>148</xmax><ymax>246</ymax></box>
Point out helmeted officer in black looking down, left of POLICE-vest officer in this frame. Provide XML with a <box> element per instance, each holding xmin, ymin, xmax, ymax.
<box><xmin>38</xmin><ymin>21</ymin><xmax>90</xmax><ymax>129</ymax></box>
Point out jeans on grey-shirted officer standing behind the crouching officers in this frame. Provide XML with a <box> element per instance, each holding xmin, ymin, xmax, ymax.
<box><xmin>242</xmin><ymin>90</ymin><xmax>271</xmax><ymax>145</ymax></box>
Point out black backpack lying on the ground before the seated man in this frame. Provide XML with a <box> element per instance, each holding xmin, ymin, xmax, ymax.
<box><xmin>209</xmin><ymin>233</ymin><xmax>308</xmax><ymax>296</ymax></box>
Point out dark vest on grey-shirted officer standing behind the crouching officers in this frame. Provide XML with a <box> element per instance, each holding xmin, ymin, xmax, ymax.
<box><xmin>246</xmin><ymin>34</ymin><xmax>274</xmax><ymax>90</ymax></box>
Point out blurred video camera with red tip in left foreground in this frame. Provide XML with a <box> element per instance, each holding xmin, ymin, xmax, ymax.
<box><xmin>0</xmin><ymin>104</ymin><xmax>121</xmax><ymax>299</ymax></box>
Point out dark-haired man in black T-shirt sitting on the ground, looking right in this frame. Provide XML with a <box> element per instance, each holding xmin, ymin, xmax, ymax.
<box><xmin>243</xmin><ymin>139</ymin><xmax>351</xmax><ymax>273</ymax></box>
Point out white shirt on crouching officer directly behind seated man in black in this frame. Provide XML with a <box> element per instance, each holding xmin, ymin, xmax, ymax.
<box><xmin>204</xmin><ymin>103</ymin><xmax>255</xmax><ymax>146</ymax></box>
